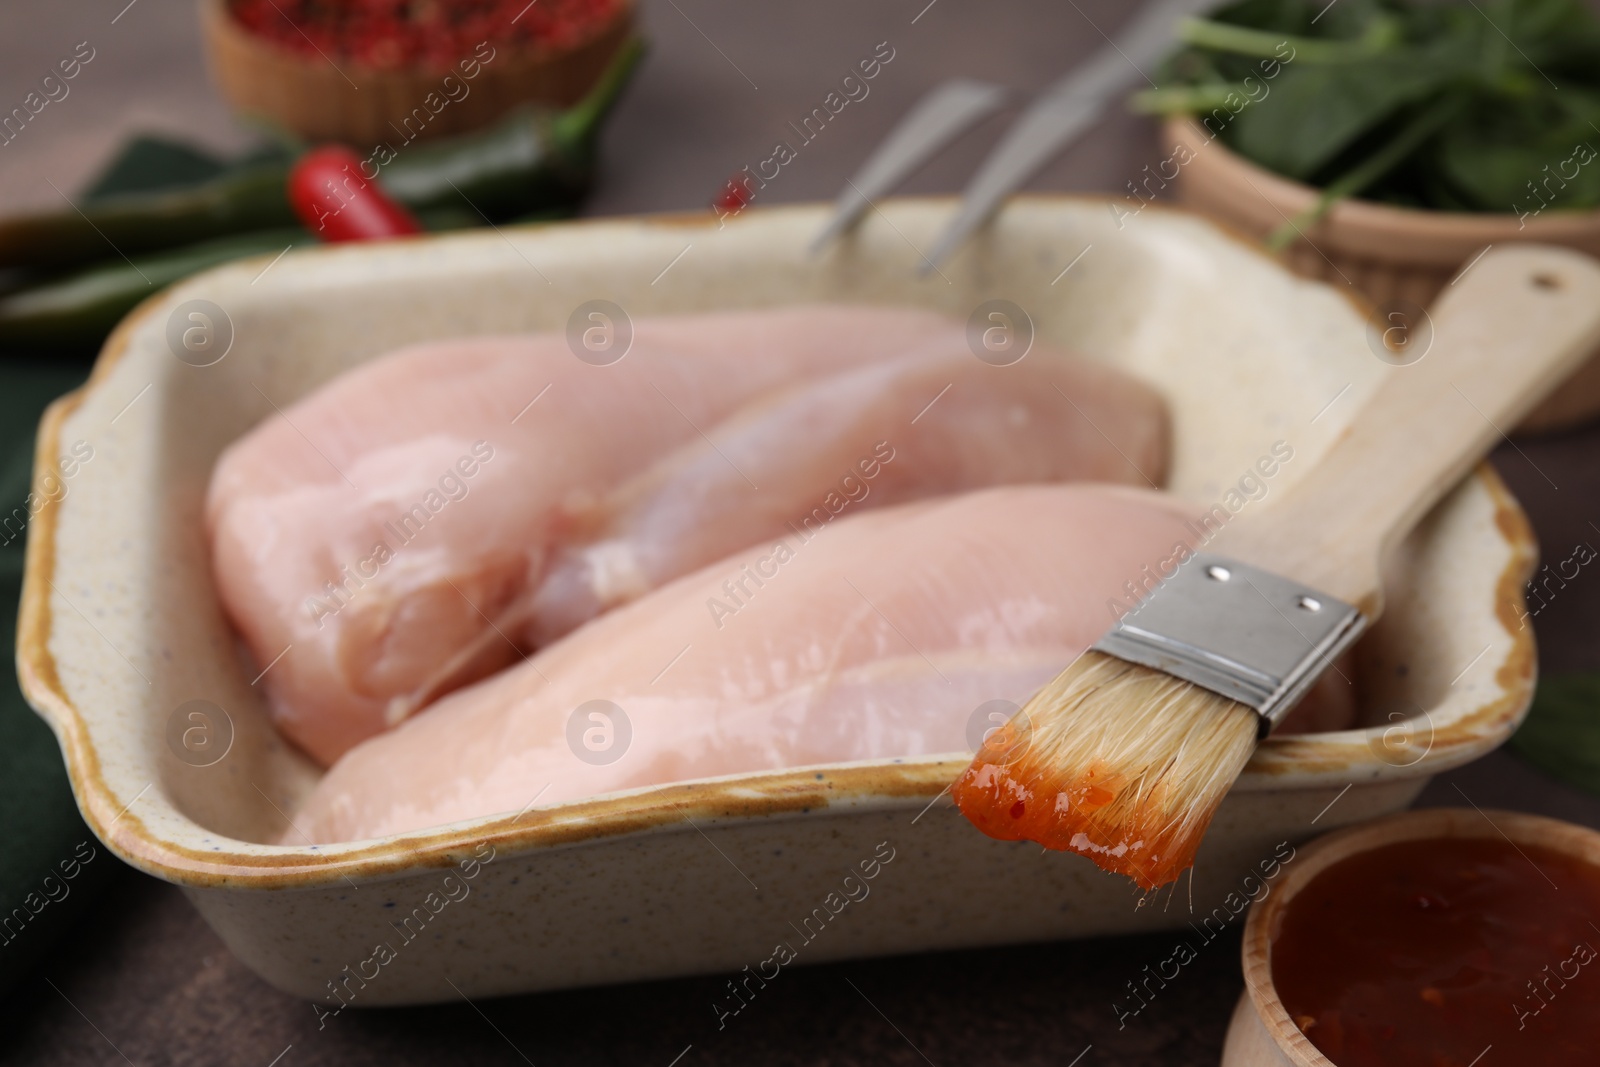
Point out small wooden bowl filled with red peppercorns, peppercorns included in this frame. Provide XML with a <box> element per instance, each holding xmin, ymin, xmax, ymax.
<box><xmin>200</xmin><ymin>0</ymin><xmax>634</xmax><ymax>150</ymax></box>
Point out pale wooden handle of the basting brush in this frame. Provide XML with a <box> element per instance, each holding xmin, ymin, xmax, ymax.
<box><xmin>1214</xmin><ymin>245</ymin><xmax>1600</xmax><ymax>616</ymax></box>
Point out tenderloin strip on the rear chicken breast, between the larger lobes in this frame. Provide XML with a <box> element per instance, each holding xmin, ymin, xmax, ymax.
<box><xmin>531</xmin><ymin>334</ymin><xmax>1168</xmax><ymax>645</ymax></box>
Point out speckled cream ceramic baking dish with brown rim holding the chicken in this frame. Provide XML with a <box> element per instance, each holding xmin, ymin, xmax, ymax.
<box><xmin>18</xmin><ymin>197</ymin><xmax>1534</xmax><ymax>1011</ymax></box>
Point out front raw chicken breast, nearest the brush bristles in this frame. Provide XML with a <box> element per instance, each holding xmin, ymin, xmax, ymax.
<box><xmin>294</xmin><ymin>485</ymin><xmax>1194</xmax><ymax>843</ymax></box>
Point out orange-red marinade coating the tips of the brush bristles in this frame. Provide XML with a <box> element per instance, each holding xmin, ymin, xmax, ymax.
<box><xmin>950</xmin><ymin>739</ymin><xmax>1211</xmax><ymax>889</ymax></box>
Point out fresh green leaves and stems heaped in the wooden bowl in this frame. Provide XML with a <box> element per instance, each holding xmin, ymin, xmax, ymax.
<box><xmin>1133</xmin><ymin>0</ymin><xmax>1600</xmax><ymax>245</ymax></box>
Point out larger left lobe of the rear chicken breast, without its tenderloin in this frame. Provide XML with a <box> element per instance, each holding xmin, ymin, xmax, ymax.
<box><xmin>206</xmin><ymin>307</ymin><xmax>960</xmax><ymax>763</ymax></box>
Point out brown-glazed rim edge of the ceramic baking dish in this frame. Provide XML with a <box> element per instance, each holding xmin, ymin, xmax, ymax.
<box><xmin>16</xmin><ymin>195</ymin><xmax>1538</xmax><ymax>889</ymax></box>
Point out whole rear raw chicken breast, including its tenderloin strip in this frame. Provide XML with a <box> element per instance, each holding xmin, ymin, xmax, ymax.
<box><xmin>210</xmin><ymin>307</ymin><xmax>1166</xmax><ymax>763</ymax></box>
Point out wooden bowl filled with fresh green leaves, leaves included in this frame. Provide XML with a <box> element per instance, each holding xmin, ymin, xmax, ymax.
<box><xmin>1126</xmin><ymin>0</ymin><xmax>1600</xmax><ymax>432</ymax></box>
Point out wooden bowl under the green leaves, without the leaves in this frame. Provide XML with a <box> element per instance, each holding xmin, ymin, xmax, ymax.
<box><xmin>1163</xmin><ymin>118</ymin><xmax>1600</xmax><ymax>434</ymax></box>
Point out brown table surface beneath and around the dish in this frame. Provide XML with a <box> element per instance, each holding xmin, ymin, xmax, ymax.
<box><xmin>0</xmin><ymin>0</ymin><xmax>1600</xmax><ymax>1067</ymax></box>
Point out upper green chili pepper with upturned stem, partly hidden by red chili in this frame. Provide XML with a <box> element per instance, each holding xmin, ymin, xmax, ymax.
<box><xmin>0</xmin><ymin>38</ymin><xmax>645</xmax><ymax>275</ymax></box>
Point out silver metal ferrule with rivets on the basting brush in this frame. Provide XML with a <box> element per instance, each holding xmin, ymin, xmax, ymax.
<box><xmin>1094</xmin><ymin>552</ymin><xmax>1366</xmax><ymax>737</ymax></box>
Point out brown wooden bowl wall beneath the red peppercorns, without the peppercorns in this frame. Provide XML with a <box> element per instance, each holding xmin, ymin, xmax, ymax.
<box><xmin>200</xmin><ymin>0</ymin><xmax>634</xmax><ymax>147</ymax></box>
